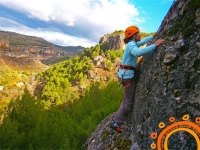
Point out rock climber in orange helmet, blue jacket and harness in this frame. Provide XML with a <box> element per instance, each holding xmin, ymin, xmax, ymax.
<box><xmin>112</xmin><ymin>26</ymin><xmax>164</xmax><ymax>133</ymax></box>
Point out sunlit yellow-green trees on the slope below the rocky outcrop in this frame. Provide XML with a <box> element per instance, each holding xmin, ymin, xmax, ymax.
<box><xmin>37</xmin><ymin>44</ymin><xmax>123</xmax><ymax>108</ymax></box>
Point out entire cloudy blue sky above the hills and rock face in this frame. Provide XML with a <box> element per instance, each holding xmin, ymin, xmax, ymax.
<box><xmin>0</xmin><ymin>0</ymin><xmax>174</xmax><ymax>47</ymax></box>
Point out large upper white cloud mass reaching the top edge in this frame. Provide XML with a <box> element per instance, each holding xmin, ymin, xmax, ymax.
<box><xmin>0</xmin><ymin>0</ymin><xmax>145</xmax><ymax>40</ymax></box>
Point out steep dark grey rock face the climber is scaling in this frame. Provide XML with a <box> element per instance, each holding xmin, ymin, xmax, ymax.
<box><xmin>86</xmin><ymin>0</ymin><xmax>200</xmax><ymax>150</ymax></box>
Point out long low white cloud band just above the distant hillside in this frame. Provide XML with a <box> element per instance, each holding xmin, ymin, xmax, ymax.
<box><xmin>0</xmin><ymin>17</ymin><xmax>95</xmax><ymax>47</ymax></box>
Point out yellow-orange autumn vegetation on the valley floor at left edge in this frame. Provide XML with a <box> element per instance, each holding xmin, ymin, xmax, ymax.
<box><xmin>0</xmin><ymin>60</ymin><xmax>48</xmax><ymax>120</ymax></box>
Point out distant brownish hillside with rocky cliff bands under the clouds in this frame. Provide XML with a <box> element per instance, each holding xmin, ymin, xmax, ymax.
<box><xmin>0</xmin><ymin>31</ymin><xmax>85</xmax><ymax>67</ymax></box>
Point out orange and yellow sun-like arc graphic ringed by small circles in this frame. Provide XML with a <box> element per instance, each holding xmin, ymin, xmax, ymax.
<box><xmin>151</xmin><ymin>114</ymin><xmax>200</xmax><ymax>150</ymax></box>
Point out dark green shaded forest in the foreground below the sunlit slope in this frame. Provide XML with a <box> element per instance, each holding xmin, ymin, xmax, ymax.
<box><xmin>0</xmin><ymin>82</ymin><xmax>123</xmax><ymax>150</ymax></box>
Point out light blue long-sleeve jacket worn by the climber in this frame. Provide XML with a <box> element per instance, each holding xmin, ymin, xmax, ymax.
<box><xmin>117</xmin><ymin>36</ymin><xmax>156</xmax><ymax>79</ymax></box>
